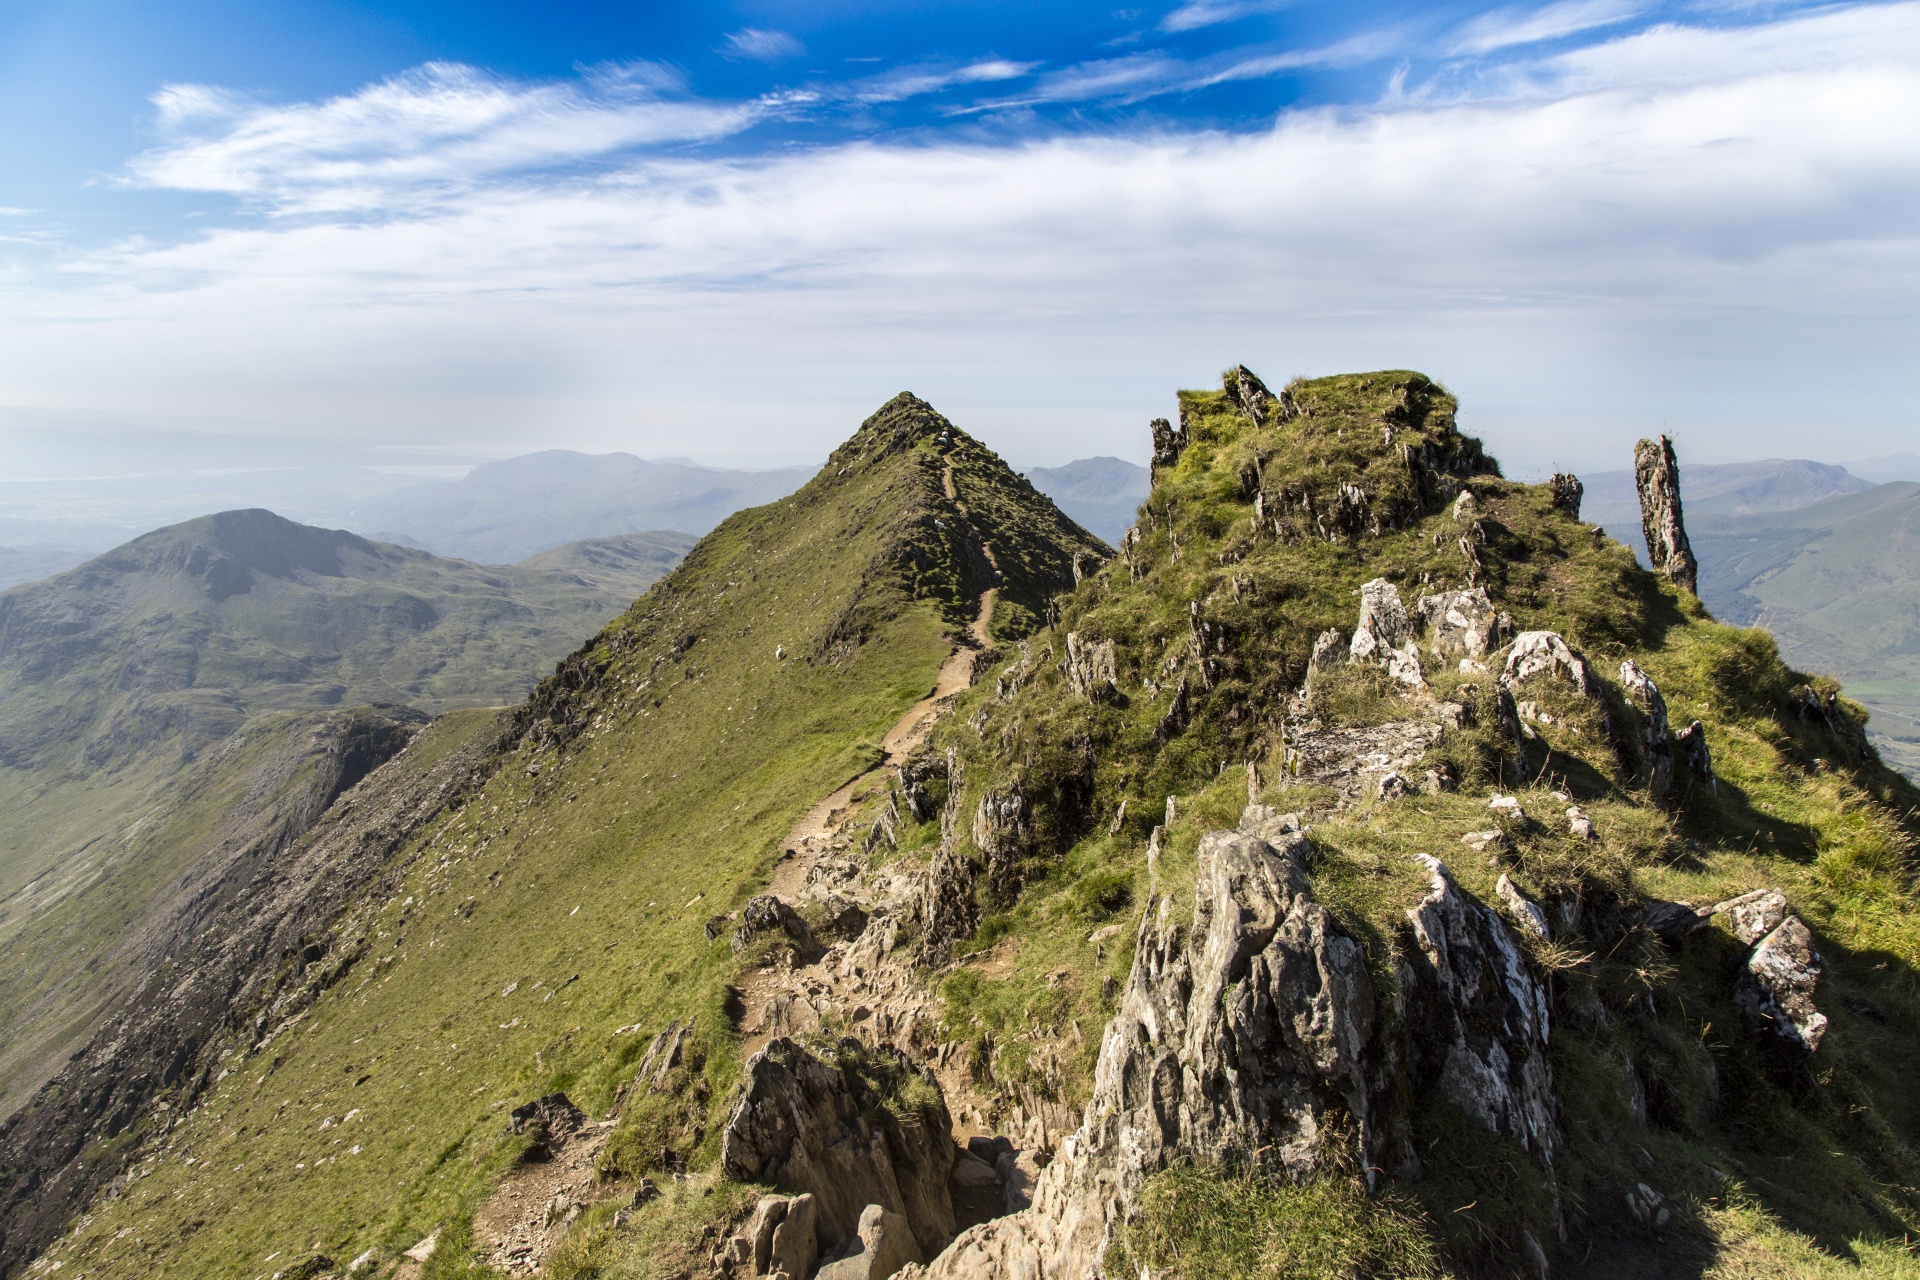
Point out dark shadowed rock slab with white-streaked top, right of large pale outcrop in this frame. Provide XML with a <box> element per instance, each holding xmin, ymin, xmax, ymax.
<box><xmin>1400</xmin><ymin>856</ymin><xmax>1559</xmax><ymax>1159</ymax></box>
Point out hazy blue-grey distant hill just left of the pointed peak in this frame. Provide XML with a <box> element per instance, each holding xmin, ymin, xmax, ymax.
<box><xmin>348</xmin><ymin>449</ymin><xmax>816</xmax><ymax>564</ymax></box>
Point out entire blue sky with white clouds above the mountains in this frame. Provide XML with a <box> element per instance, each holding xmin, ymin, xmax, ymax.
<box><xmin>0</xmin><ymin>0</ymin><xmax>1920</xmax><ymax>470</ymax></box>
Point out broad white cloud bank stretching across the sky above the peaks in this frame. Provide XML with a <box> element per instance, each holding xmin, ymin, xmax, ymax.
<box><xmin>0</xmin><ymin>6</ymin><xmax>1920</xmax><ymax>461</ymax></box>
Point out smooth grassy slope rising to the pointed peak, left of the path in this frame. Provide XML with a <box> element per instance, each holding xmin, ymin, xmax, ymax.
<box><xmin>26</xmin><ymin>395</ymin><xmax>1098</xmax><ymax>1276</ymax></box>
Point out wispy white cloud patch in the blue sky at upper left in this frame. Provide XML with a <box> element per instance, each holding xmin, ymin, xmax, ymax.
<box><xmin>129</xmin><ymin>63</ymin><xmax>760</xmax><ymax>213</ymax></box>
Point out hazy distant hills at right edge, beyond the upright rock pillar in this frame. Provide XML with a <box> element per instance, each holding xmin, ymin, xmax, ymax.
<box><xmin>1686</xmin><ymin>483</ymin><xmax>1920</xmax><ymax>777</ymax></box>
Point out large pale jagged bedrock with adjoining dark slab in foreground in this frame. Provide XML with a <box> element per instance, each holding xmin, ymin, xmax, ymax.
<box><xmin>900</xmin><ymin>821</ymin><xmax>1559</xmax><ymax>1280</ymax></box>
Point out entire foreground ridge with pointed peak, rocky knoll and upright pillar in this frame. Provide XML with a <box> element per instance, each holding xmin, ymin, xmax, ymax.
<box><xmin>0</xmin><ymin>378</ymin><xmax>1920</xmax><ymax>1280</ymax></box>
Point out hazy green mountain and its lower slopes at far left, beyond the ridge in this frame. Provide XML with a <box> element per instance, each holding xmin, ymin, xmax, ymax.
<box><xmin>0</xmin><ymin>510</ymin><xmax>693</xmax><ymax>1115</ymax></box>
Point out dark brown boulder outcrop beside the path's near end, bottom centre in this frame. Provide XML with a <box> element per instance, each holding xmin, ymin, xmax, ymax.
<box><xmin>720</xmin><ymin>1038</ymin><xmax>954</xmax><ymax>1274</ymax></box>
